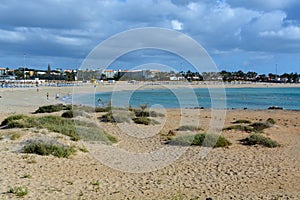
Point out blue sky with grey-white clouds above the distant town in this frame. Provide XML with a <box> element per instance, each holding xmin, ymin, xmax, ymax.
<box><xmin>0</xmin><ymin>0</ymin><xmax>300</xmax><ymax>73</ymax></box>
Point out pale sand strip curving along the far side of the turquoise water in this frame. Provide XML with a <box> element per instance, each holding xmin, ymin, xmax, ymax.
<box><xmin>0</xmin><ymin>82</ymin><xmax>300</xmax><ymax>114</ymax></box>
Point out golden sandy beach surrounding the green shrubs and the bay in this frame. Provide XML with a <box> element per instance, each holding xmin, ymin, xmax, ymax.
<box><xmin>0</xmin><ymin>83</ymin><xmax>300</xmax><ymax>200</ymax></box>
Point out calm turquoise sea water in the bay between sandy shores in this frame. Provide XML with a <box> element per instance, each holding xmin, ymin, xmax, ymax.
<box><xmin>69</xmin><ymin>88</ymin><xmax>300</xmax><ymax>110</ymax></box>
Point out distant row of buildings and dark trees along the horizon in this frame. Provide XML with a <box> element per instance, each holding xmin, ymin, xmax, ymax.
<box><xmin>0</xmin><ymin>65</ymin><xmax>300</xmax><ymax>84</ymax></box>
